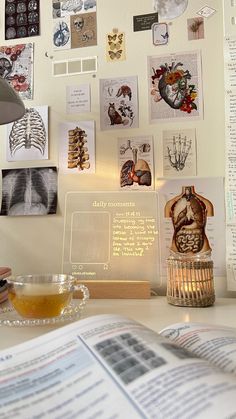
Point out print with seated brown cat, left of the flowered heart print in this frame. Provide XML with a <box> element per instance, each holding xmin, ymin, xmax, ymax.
<box><xmin>100</xmin><ymin>76</ymin><xmax>139</xmax><ymax>130</ymax></box>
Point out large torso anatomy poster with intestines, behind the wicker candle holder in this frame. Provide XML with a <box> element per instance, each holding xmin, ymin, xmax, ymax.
<box><xmin>156</xmin><ymin>177</ymin><xmax>226</xmax><ymax>276</ymax></box>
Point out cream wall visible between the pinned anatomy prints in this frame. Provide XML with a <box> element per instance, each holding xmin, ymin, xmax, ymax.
<box><xmin>0</xmin><ymin>0</ymin><xmax>230</xmax><ymax>293</ymax></box>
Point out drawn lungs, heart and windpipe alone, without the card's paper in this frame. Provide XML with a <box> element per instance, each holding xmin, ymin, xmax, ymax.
<box><xmin>120</xmin><ymin>140</ymin><xmax>152</xmax><ymax>187</ymax></box>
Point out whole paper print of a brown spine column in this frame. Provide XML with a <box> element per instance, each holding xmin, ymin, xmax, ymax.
<box><xmin>59</xmin><ymin>121</ymin><xmax>95</xmax><ymax>174</ymax></box>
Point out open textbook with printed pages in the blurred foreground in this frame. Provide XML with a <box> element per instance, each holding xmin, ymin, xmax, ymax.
<box><xmin>0</xmin><ymin>315</ymin><xmax>236</xmax><ymax>419</ymax></box>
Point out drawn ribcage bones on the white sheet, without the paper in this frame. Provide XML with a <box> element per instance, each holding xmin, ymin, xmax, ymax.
<box><xmin>9</xmin><ymin>108</ymin><xmax>46</xmax><ymax>156</ymax></box>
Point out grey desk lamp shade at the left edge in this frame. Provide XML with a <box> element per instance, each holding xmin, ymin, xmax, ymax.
<box><xmin>0</xmin><ymin>77</ymin><xmax>25</xmax><ymax>125</ymax></box>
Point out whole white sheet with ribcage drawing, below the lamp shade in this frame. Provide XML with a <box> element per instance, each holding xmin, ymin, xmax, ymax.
<box><xmin>6</xmin><ymin>106</ymin><xmax>48</xmax><ymax>161</ymax></box>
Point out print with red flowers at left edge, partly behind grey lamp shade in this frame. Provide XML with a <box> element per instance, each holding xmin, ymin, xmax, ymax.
<box><xmin>0</xmin><ymin>43</ymin><xmax>33</xmax><ymax>99</ymax></box>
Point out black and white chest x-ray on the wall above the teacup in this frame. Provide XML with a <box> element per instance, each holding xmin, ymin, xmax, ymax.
<box><xmin>0</xmin><ymin>167</ymin><xmax>57</xmax><ymax>216</ymax></box>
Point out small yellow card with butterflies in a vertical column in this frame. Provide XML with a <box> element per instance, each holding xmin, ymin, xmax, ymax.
<box><xmin>106</xmin><ymin>31</ymin><xmax>125</xmax><ymax>62</ymax></box>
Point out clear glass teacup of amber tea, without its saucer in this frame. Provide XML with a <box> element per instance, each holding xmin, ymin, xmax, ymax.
<box><xmin>7</xmin><ymin>274</ymin><xmax>89</xmax><ymax>319</ymax></box>
